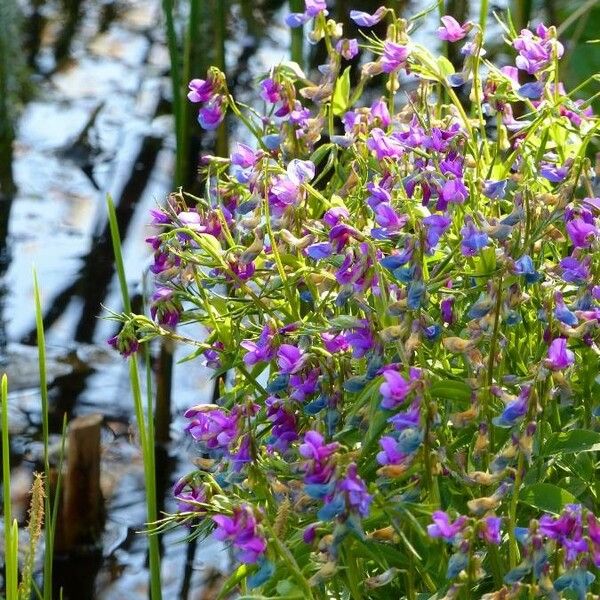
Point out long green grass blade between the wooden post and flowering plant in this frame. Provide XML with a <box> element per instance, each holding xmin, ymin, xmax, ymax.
<box><xmin>106</xmin><ymin>195</ymin><xmax>162</xmax><ymax>600</ymax></box>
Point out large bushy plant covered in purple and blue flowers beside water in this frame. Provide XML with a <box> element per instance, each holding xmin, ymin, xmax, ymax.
<box><xmin>113</xmin><ymin>0</ymin><xmax>600</xmax><ymax>599</ymax></box>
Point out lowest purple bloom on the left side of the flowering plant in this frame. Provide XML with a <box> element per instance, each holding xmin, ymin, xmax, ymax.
<box><xmin>212</xmin><ymin>504</ymin><xmax>267</xmax><ymax>563</ymax></box>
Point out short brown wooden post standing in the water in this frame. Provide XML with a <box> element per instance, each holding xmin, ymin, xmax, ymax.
<box><xmin>57</xmin><ymin>414</ymin><xmax>104</xmax><ymax>552</ymax></box>
